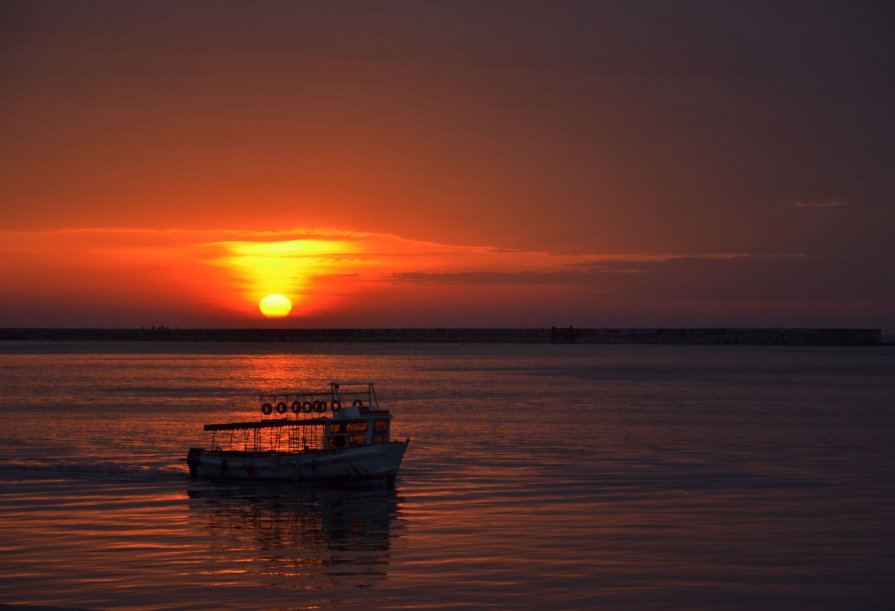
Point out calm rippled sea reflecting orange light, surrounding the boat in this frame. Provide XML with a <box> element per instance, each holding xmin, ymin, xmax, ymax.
<box><xmin>0</xmin><ymin>342</ymin><xmax>895</xmax><ymax>609</ymax></box>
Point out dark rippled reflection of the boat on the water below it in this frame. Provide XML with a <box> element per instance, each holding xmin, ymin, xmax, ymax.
<box><xmin>188</xmin><ymin>482</ymin><xmax>402</xmax><ymax>591</ymax></box>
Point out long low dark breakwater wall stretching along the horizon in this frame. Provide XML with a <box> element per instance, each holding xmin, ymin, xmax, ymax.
<box><xmin>0</xmin><ymin>327</ymin><xmax>883</xmax><ymax>346</ymax></box>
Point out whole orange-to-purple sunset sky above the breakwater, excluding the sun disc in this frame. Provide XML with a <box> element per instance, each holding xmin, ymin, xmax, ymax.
<box><xmin>0</xmin><ymin>0</ymin><xmax>895</xmax><ymax>329</ymax></box>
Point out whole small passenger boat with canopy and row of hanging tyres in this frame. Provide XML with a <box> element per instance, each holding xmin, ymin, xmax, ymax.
<box><xmin>186</xmin><ymin>380</ymin><xmax>410</xmax><ymax>486</ymax></box>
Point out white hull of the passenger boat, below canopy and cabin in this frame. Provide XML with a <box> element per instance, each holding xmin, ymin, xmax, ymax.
<box><xmin>187</xmin><ymin>440</ymin><xmax>409</xmax><ymax>483</ymax></box>
